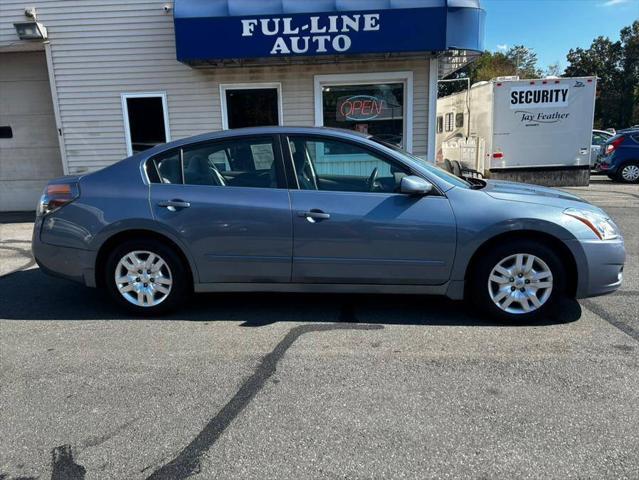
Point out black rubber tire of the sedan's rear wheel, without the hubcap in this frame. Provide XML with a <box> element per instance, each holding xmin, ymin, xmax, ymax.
<box><xmin>103</xmin><ymin>238</ymin><xmax>192</xmax><ymax>316</ymax></box>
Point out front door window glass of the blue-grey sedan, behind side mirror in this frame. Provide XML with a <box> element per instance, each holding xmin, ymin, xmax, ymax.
<box><xmin>288</xmin><ymin>137</ymin><xmax>409</xmax><ymax>193</ymax></box>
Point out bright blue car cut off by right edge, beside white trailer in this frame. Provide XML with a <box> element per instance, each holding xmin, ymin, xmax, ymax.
<box><xmin>598</xmin><ymin>129</ymin><xmax>639</xmax><ymax>183</ymax></box>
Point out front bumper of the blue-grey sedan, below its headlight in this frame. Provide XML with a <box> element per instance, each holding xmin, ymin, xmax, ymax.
<box><xmin>572</xmin><ymin>238</ymin><xmax>626</xmax><ymax>298</ymax></box>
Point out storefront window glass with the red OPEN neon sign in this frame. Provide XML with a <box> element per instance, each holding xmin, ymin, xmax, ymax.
<box><xmin>322</xmin><ymin>83</ymin><xmax>404</xmax><ymax>145</ymax></box>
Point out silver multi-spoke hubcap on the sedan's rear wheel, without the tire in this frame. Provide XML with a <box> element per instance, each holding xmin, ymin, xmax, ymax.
<box><xmin>115</xmin><ymin>250</ymin><xmax>173</xmax><ymax>307</ymax></box>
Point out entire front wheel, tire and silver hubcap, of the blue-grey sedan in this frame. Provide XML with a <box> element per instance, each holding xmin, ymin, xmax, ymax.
<box><xmin>470</xmin><ymin>240</ymin><xmax>566</xmax><ymax>321</ymax></box>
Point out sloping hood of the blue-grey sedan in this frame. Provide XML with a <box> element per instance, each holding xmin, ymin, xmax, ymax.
<box><xmin>482</xmin><ymin>180</ymin><xmax>599</xmax><ymax>210</ymax></box>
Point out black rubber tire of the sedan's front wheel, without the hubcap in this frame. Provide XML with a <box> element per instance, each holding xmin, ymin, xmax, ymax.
<box><xmin>467</xmin><ymin>240</ymin><xmax>567</xmax><ymax>322</ymax></box>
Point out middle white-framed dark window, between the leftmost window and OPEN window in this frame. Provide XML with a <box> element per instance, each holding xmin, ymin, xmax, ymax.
<box><xmin>220</xmin><ymin>83</ymin><xmax>282</xmax><ymax>130</ymax></box>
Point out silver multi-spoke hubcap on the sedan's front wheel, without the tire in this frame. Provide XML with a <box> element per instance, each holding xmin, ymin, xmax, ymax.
<box><xmin>488</xmin><ymin>253</ymin><xmax>553</xmax><ymax>315</ymax></box>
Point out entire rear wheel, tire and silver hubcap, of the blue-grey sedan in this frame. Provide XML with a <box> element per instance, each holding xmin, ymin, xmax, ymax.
<box><xmin>104</xmin><ymin>239</ymin><xmax>189</xmax><ymax>315</ymax></box>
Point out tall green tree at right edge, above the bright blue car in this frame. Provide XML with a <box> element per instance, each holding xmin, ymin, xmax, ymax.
<box><xmin>565</xmin><ymin>21</ymin><xmax>639</xmax><ymax>128</ymax></box>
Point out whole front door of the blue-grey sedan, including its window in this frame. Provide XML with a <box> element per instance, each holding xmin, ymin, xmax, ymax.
<box><xmin>285</xmin><ymin>136</ymin><xmax>456</xmax><ymax>285</ymax></box>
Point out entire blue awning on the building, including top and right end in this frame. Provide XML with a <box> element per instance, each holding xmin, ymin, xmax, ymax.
<box><xmin>174</xmin><ymin>0</ymin><xmax>485</xmax><ymax>63</ymax></box>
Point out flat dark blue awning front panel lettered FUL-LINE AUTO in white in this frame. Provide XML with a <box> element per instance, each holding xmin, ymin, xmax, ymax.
<box><xmin>175</xmin><ymin>8</ymin><xmax>447</xmax><ymax>61</ymax></box>
